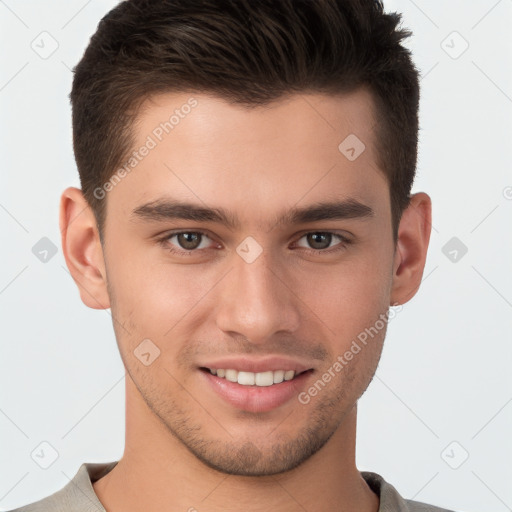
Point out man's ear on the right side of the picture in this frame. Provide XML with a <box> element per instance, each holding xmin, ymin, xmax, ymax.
<box><xmin>391</xmin><ymin>192</ymin><xmax>432</xmax><ymax>306</ymax></box>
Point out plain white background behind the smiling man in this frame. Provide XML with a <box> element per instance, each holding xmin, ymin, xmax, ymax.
<box><xmin>0</xmin><ymin>0</ymin><xmax>512</xmax><ymax>512</ymax></box>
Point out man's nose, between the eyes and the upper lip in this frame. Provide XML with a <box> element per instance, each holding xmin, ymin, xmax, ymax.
<box><xmin>216</xmin><ymin>251</ymin><xmax>300</xmax><ymax>344</ymax></box>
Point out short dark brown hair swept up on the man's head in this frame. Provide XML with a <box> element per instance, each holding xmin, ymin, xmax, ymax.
<box><xmin>70</xmin><ymin>0</ymin><xmax>419</xmax><ymax>240</ymax></box>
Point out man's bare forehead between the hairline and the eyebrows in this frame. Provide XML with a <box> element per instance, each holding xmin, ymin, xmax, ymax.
<box><xmin>109</xmin><ymin>90</ymin><xmax>388</xmax><ymax>227</ymax></box>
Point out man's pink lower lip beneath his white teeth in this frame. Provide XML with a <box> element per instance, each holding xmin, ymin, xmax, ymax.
<box><xmin>200</xmin><ymin>370</ymin><xmax>312</xmax><ymax>412</ymax></box>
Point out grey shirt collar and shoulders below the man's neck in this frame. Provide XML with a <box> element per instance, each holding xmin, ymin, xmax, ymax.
<box><xmin>10</xmin><ymin>461</ymin><xmax>453</xmax><ymax>512</ymax></box>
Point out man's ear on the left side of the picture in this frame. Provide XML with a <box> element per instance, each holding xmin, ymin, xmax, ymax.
<box><xmin>60</xmin><ymin>187</ymin><xmax>110</xmax><ymax>309</ymax></box>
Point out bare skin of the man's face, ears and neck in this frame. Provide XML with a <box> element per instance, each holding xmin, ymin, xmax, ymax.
<box><xmin>60</xmin><ymin>89</ymin><xmax>431</xmax><ymax>512</ymax></box>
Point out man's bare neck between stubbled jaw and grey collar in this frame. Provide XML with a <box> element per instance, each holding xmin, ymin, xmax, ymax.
<box><xmin>93</xmin><ymin>374</ymin><xmax>379</xmax><ymax>512</ymax></box>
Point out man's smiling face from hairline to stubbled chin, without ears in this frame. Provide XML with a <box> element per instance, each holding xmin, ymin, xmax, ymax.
<box><xmin>103</xmin><ymin>90</ymin><xmax>394</xmax><ymax>475</ymax></box>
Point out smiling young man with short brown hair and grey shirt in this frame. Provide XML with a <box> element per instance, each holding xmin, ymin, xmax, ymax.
<box><xmin>9</xmin><ymin>0</ymin><xmax>456</xmax><ymax>512</ymax></box>
